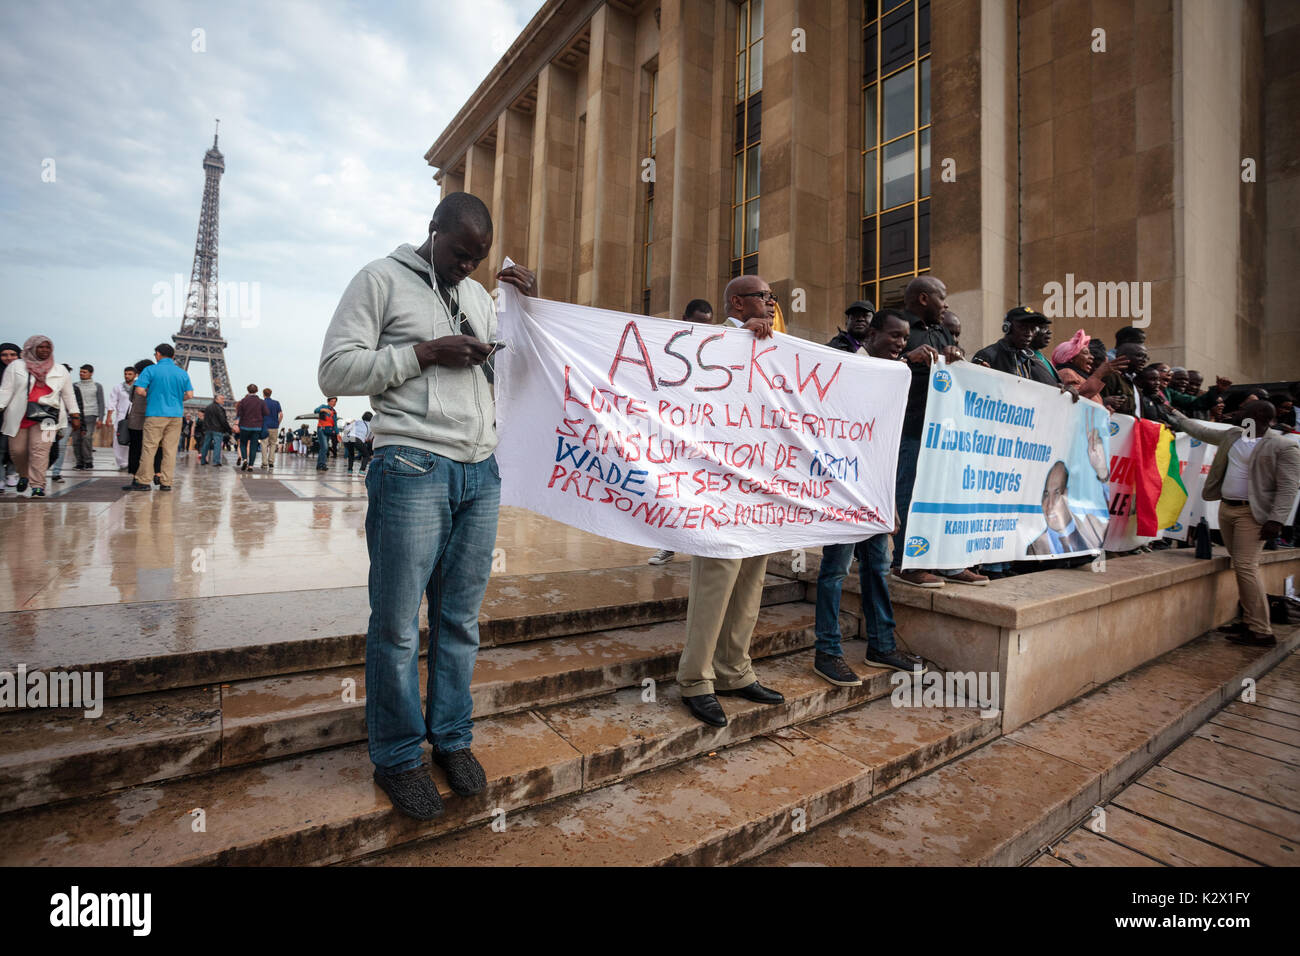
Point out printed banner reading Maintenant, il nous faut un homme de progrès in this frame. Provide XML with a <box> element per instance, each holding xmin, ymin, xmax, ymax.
<box><xmin>902</xmin><ymin>362</ymin><xmax>1109</xmax><ymax>570</ymax></box>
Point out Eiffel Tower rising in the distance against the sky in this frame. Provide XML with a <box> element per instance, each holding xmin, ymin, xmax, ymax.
<box><xmin>172</xmin><ymin>120</ymin><xmax>234</xmax><ymax>408</ymax></box>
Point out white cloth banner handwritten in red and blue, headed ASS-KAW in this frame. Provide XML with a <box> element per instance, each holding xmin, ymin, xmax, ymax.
<box><xmin>495</xmin><ymin>285</ymin><xmax>910</xmax><ymax>558</ymax></box>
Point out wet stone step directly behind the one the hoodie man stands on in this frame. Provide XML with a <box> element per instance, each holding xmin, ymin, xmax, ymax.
<box><xmin>0</xmin><ymin>604</ymin><xmax>842</xmax><ymax>813</ymax></box>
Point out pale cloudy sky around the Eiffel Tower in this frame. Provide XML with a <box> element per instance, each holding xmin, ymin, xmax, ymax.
<box><xmin>0</xmin><ymin>0</ymin><xmax>541</xmax><ymax>418</ymax></box>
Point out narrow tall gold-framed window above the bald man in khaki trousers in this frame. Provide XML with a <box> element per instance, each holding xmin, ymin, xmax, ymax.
<box><xmin>731</xmin><ymin>0</ymin><xmax>763</xmax><ymax>278</ymax></box>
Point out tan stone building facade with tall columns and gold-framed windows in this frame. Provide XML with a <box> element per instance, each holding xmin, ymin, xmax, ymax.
<box><xmin>425</xmin><ymin>0</ymin><xmax>1300</xmax><ymax>381</ymax></box>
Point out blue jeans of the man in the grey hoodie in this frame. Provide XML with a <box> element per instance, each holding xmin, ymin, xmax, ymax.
<box><xmin>365</xmin><ymin>445</ymin><xmax>501</xmax><ymax>773</ymax></box>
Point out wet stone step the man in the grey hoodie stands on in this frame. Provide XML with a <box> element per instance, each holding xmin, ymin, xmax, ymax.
<box><xmin>0</xmin><ymin>641</ymin><xmax>915</xmax><ymax>866</ymax></box>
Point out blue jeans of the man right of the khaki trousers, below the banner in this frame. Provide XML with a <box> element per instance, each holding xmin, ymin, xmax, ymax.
<box><xmin>816</xmin><ymin>535</ymin><xmax>897</xmax><ymax>657</ymax></box>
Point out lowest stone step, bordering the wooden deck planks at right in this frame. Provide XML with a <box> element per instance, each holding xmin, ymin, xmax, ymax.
<box><xmin>754</xmin><ymin>616</ymin><xmax>1300</xmax><ymax>866</ymax></box>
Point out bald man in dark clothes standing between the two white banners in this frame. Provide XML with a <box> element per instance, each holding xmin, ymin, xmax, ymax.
<box><xmin>892</xmin><ymin>276</ymin><xmax>988</xmax><ymax>588</ymax></box>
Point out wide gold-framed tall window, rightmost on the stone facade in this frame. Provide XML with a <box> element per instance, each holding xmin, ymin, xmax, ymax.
<box><xmin>861</xmin><ymin>0</ymin><xmax>930</xmax><ymax>308</ymax></box>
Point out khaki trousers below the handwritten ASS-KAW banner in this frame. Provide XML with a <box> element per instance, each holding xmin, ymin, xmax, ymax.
<box><xmin>677</xmin><ymin>554</ymin><xmax>767</xmax><ymax>697</ymax></box>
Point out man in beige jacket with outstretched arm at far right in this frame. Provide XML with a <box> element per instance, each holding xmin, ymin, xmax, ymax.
<box><xmin>1167</xmin><ymin>401</ymin><xmax>1300</xmax><ymax>648</ymax></box>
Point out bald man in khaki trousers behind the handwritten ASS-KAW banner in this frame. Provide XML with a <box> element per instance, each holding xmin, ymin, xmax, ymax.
<box><xmin>677</xmin><ymin>276</ymin><xmax>785</xmax><ymax>727</ymax></box>
